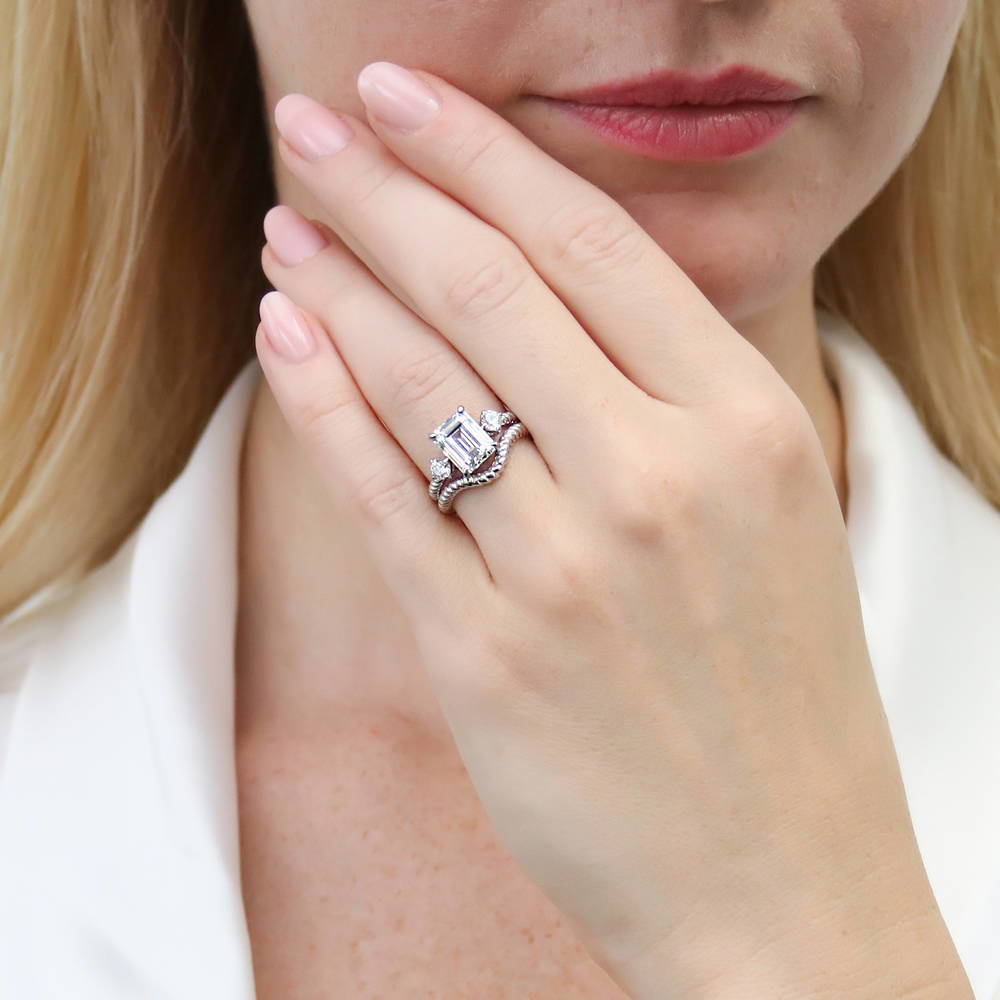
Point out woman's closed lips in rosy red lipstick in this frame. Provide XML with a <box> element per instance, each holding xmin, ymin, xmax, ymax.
<box><xmin>543</xmin><ymin>65</ymin><xmax>813</xmax><ymax>160</ymax></box>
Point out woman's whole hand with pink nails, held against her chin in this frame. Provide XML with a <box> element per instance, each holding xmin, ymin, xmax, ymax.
<box><xmin>257</xmin><ymin>63</ymin><xmax>969</xmax><ymax>1000</ymax></box>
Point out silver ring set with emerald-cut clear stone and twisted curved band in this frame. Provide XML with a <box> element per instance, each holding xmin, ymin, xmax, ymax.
<box><xmin>427</xmin><ymin>406</ymin><xmax>527</xmax><ymax>514</ymax></box>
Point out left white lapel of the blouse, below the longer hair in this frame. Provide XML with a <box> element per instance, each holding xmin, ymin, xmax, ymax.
<box><xmin>0</xmin><ymin>358</ymin><xmax>262</xmax><ymax>1000</ymax></box>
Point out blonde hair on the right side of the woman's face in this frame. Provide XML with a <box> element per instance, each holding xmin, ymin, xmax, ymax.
<box><xmin>815</xmin><ymin>0</ymin><xmax>1000</xmax><ymax>507</ymax></box>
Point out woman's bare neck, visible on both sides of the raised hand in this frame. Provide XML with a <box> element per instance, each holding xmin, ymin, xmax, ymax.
<box><xmin>236</xmin><ymin>285</ymin><xmax>847</xmax><ymax>736</ymax></box>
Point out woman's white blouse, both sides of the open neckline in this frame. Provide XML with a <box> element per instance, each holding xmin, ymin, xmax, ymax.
<box><xmin>0</xmin><ymin>310</ymin><xmax>1000</xmax><ymax>1000</ymax></box>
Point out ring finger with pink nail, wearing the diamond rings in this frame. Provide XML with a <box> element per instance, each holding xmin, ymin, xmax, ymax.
<box><xmin>261</xmin><ymin>205</ymin><xmax>556</xmax><ymax>567</ymax></box>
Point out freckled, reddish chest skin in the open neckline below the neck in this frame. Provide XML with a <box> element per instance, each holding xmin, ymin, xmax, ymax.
<box><xmin>237</xmin><ymin>710</ymin><xmax>625</xmax><ymax>1000</ymax></box>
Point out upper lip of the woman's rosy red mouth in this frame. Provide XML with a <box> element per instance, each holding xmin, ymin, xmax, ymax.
<box><xmin>553</xmin><ymin>65</ymin><xmax>811</xmax><ymax>107</ymax></box>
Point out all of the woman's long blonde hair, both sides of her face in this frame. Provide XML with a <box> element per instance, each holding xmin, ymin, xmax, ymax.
<box><xmin>0</xmin><ymin>0</ymin><xmax>1000</xmax><ymax>616</ymax></box>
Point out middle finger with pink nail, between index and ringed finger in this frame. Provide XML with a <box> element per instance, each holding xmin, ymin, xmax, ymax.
<box><xmin>275</xmin><ymin>94</ymin><xmax>641</xmax><ymax>480</ymax></box>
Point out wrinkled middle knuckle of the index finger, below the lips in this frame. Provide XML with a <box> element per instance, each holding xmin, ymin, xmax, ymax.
<box><xmin>542</xmin><ymin>202</ymin><xmax>644</xmax><ymax>270</ymax></box>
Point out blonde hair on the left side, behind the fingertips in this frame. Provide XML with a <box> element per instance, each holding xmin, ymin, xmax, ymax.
<box><xmin>0</xmin><ymin>0</ymin><xmax>274</xmax><ymax>615</ymax></box>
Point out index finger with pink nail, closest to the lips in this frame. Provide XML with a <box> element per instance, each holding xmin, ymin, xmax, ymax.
<box><xmin>358</xmin><ymin>62</ymin><xmax>773</xmax><ymax>405</ymax></box>
